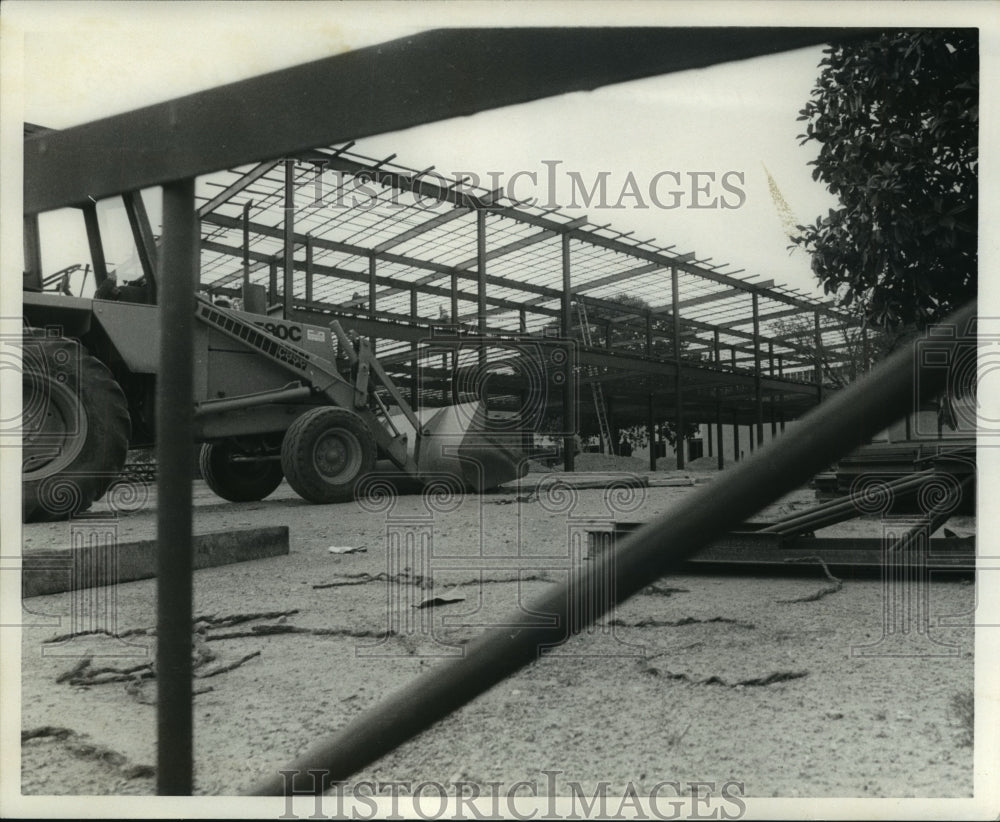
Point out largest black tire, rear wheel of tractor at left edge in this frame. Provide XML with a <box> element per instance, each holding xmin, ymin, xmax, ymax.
<box><xmin>21</xmin><ymin>331</ymin><xmax>131</xmax><ymax>522</ymax></box>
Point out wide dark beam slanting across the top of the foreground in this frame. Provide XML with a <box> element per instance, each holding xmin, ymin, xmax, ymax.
<box><xmin>24</xmin><ymin>27</ymin><xmax>863</xmax><ymax>216</ymax></box>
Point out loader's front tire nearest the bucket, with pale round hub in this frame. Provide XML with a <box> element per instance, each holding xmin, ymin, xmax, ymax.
<box><xmin>281</xmin><ymin>406</ymin><xmax>376</xmax><ymax>504</ymax></box>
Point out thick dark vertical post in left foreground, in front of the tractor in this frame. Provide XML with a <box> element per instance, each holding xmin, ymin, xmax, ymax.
<box><xmin>156</xmin><ymin>179</ymin><xmax>198</xmax><ymax>796</ymax></box>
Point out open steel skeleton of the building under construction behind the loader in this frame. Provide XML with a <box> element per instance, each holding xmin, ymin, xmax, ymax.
<box><xmin>198</xmin><ymin>143</ymin><xmax>867</xmax><ymax>467</ymax></box>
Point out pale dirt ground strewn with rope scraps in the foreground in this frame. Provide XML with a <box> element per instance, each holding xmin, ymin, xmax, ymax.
<box><xmin>22</xmin><ymin>474</ymin><xmax>974</xmax><ymax>797</ymax></box>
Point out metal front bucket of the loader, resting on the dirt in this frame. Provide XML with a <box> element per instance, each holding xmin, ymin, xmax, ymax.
<box><xmin>417</xmin><ymin>402</ymin><xmax>527</xmax><ymax>492</ymax></box>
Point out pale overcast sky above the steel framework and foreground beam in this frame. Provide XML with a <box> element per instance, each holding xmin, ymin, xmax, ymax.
<box><xmin>4</xmin><ymin>2</ymin><xmax>996</xmax><ymax>308</ymax></box>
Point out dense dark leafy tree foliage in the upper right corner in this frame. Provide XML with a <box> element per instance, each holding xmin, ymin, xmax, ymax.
<box><xmin>793</xmin><ymin>30</ymin><xmax>979</xmax><ymax>327</ymax></box>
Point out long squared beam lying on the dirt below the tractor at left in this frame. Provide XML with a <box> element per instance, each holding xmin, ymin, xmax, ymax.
<box><xmin>21</xmin><ymin>519</ymin><xmax>288</xmax><ymax>597</ymax></box>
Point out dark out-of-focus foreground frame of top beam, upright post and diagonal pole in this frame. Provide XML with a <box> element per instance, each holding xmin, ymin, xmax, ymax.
<box><xmin>24</xmin><ymin>28</ymin><xmax>976</xmax><ymax>795</ymax></box>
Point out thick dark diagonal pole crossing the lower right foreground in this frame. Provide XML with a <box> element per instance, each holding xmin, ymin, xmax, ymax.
<box><xmin>250</xmin><ymin>302</ymin><xmax>976</xmax><ymax>795</ymax></box>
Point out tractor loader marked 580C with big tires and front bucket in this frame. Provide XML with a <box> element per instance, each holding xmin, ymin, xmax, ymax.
<box><xmin>22</xmin><ymin>276</ymin><xmax>526</xmax><ymax>521</ymax></box>
